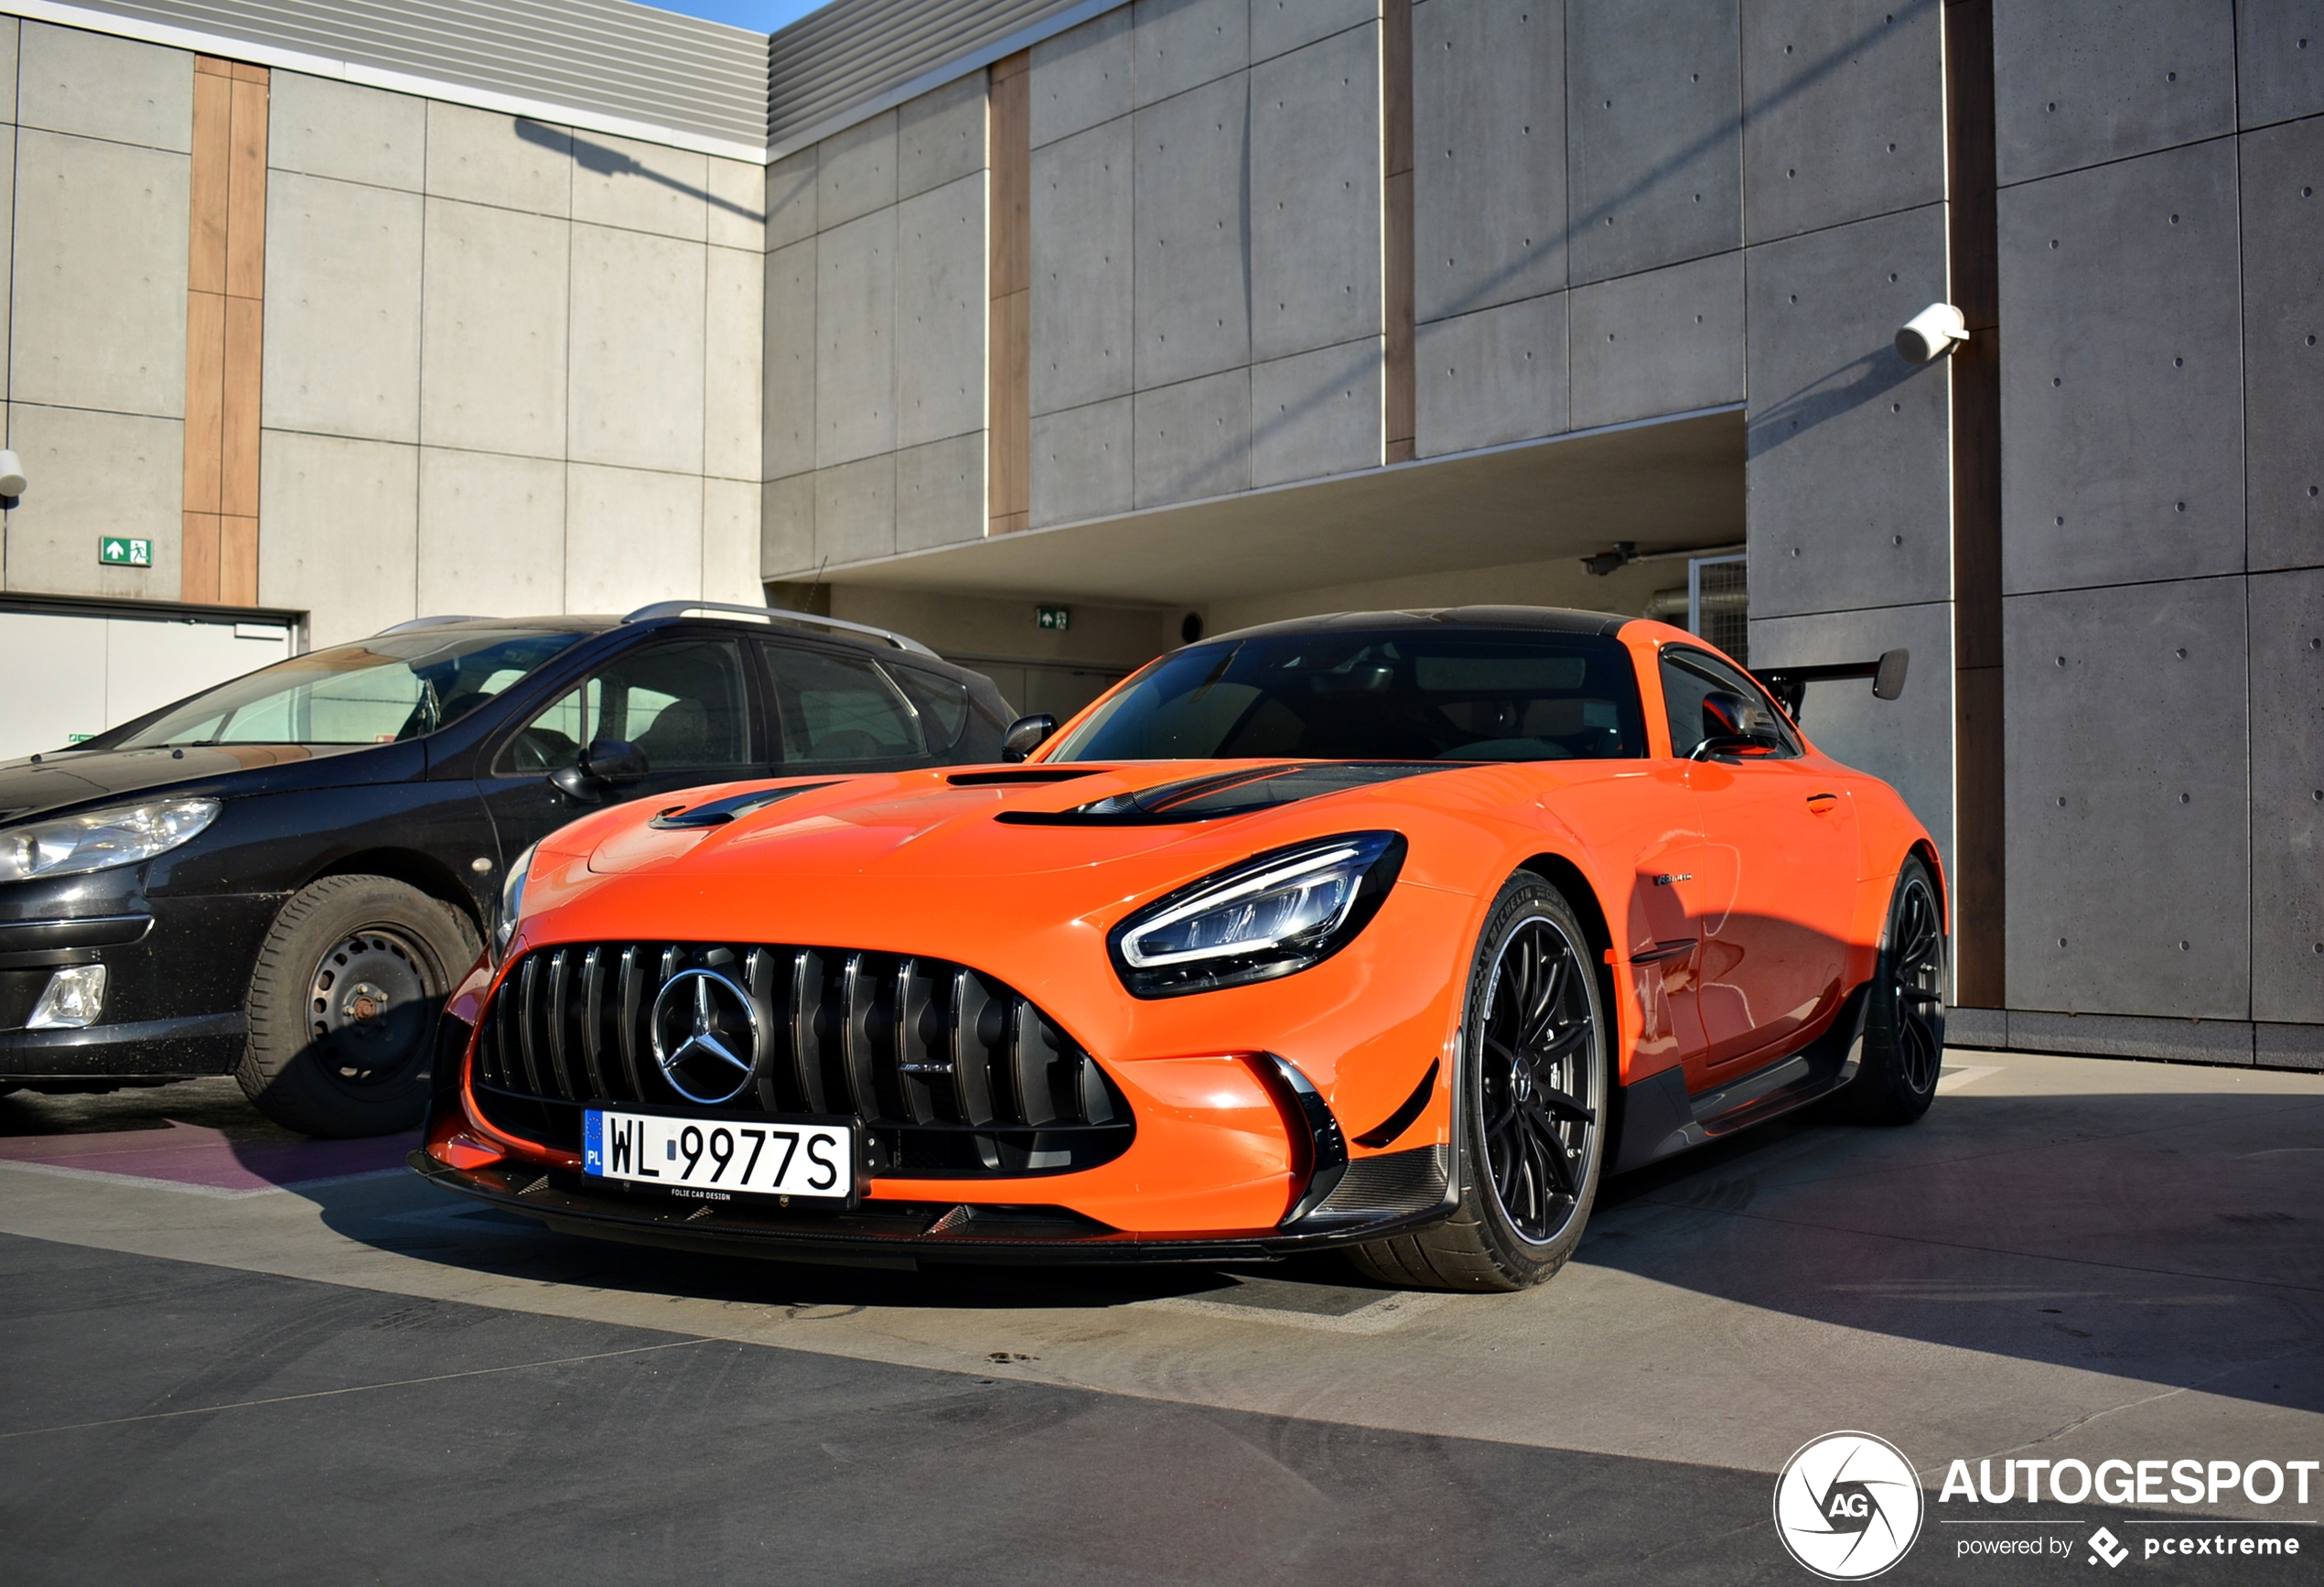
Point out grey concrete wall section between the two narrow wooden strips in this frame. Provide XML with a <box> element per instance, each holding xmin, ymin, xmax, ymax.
<box><xmin>1032</xmin><ymin>0</ymin><xmax>1383</xmax><ymax>527</ymax></box>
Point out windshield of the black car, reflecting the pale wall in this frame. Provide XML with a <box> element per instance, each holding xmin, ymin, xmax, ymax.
<box><xmin>116</xmin><ymin>627</ymin><xmax>581</xmax><ymax>750</ymax></box>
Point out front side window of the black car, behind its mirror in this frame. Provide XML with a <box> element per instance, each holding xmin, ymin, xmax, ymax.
<box><xmin>495</xmin><ymin>639</ymin><xmax>750</xmax><ymax>776</ymax></box>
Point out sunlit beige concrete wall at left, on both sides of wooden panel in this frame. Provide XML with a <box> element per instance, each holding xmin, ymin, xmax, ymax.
<box><xmin>0</xmin><ymin>18</ymin><xmax>765</xmax><ymax>643</ymax></box>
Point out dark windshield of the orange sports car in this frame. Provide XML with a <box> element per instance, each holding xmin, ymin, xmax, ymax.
<box><xmin>1043</xmin><ymin>630</ymin><xmax>1645</xmax><ymax>760</ymax></box>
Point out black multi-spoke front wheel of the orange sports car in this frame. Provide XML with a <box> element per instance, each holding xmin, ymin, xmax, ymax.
<box><xmin>1348</xmin><ymin>871</ymin><xmax>1613</xmax><ymax>1290</ymax></box>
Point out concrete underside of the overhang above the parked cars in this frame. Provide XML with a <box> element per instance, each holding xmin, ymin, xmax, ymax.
<box><xmin>823</xmin><ymin>406</ymin><xmax>1743</xmax><ymax>607</ymax></box>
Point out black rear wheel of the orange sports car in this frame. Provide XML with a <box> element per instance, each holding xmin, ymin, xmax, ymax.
<box><xmin>1832</xmin><ymin>859</ymin><xmax>1945</xmax><ymax>1125</ymax></box>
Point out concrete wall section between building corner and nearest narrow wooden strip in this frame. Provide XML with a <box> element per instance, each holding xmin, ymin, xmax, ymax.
<box><xmin>760</xmin><ymin>72</ymin><xmax>988</xmax><ymax>578</ymax></box>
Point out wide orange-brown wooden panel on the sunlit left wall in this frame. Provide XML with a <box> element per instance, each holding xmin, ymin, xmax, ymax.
<box><xmin>179</xmin><ymin>56</ymin><xmax>267</xmax><ymax>607</ymax></box>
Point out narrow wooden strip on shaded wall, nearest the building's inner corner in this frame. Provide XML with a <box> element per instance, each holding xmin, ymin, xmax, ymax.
<box><xmin>985</xmin><ymin>51</ymin><xmax>1032</xmax><ymax>534</ymax></box>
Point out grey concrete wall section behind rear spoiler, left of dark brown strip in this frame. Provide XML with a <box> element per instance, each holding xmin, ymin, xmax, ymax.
<box><xmin>1740</xmin><ymin>0</ymin><xmax>1953</xmax><ymax>887</ymax></box>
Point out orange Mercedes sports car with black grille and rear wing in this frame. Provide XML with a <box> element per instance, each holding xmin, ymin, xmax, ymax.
<box><xmin>412</xmin><ymin>607</ymin><xmax>1945</xmax><ymax>1290</ymax></box>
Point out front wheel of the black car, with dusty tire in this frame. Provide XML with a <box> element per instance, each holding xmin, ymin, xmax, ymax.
<box><xmin>235</xmin><ymin>876</ymin><xmax>479</xmax><ymax>1136</ymax></box>
